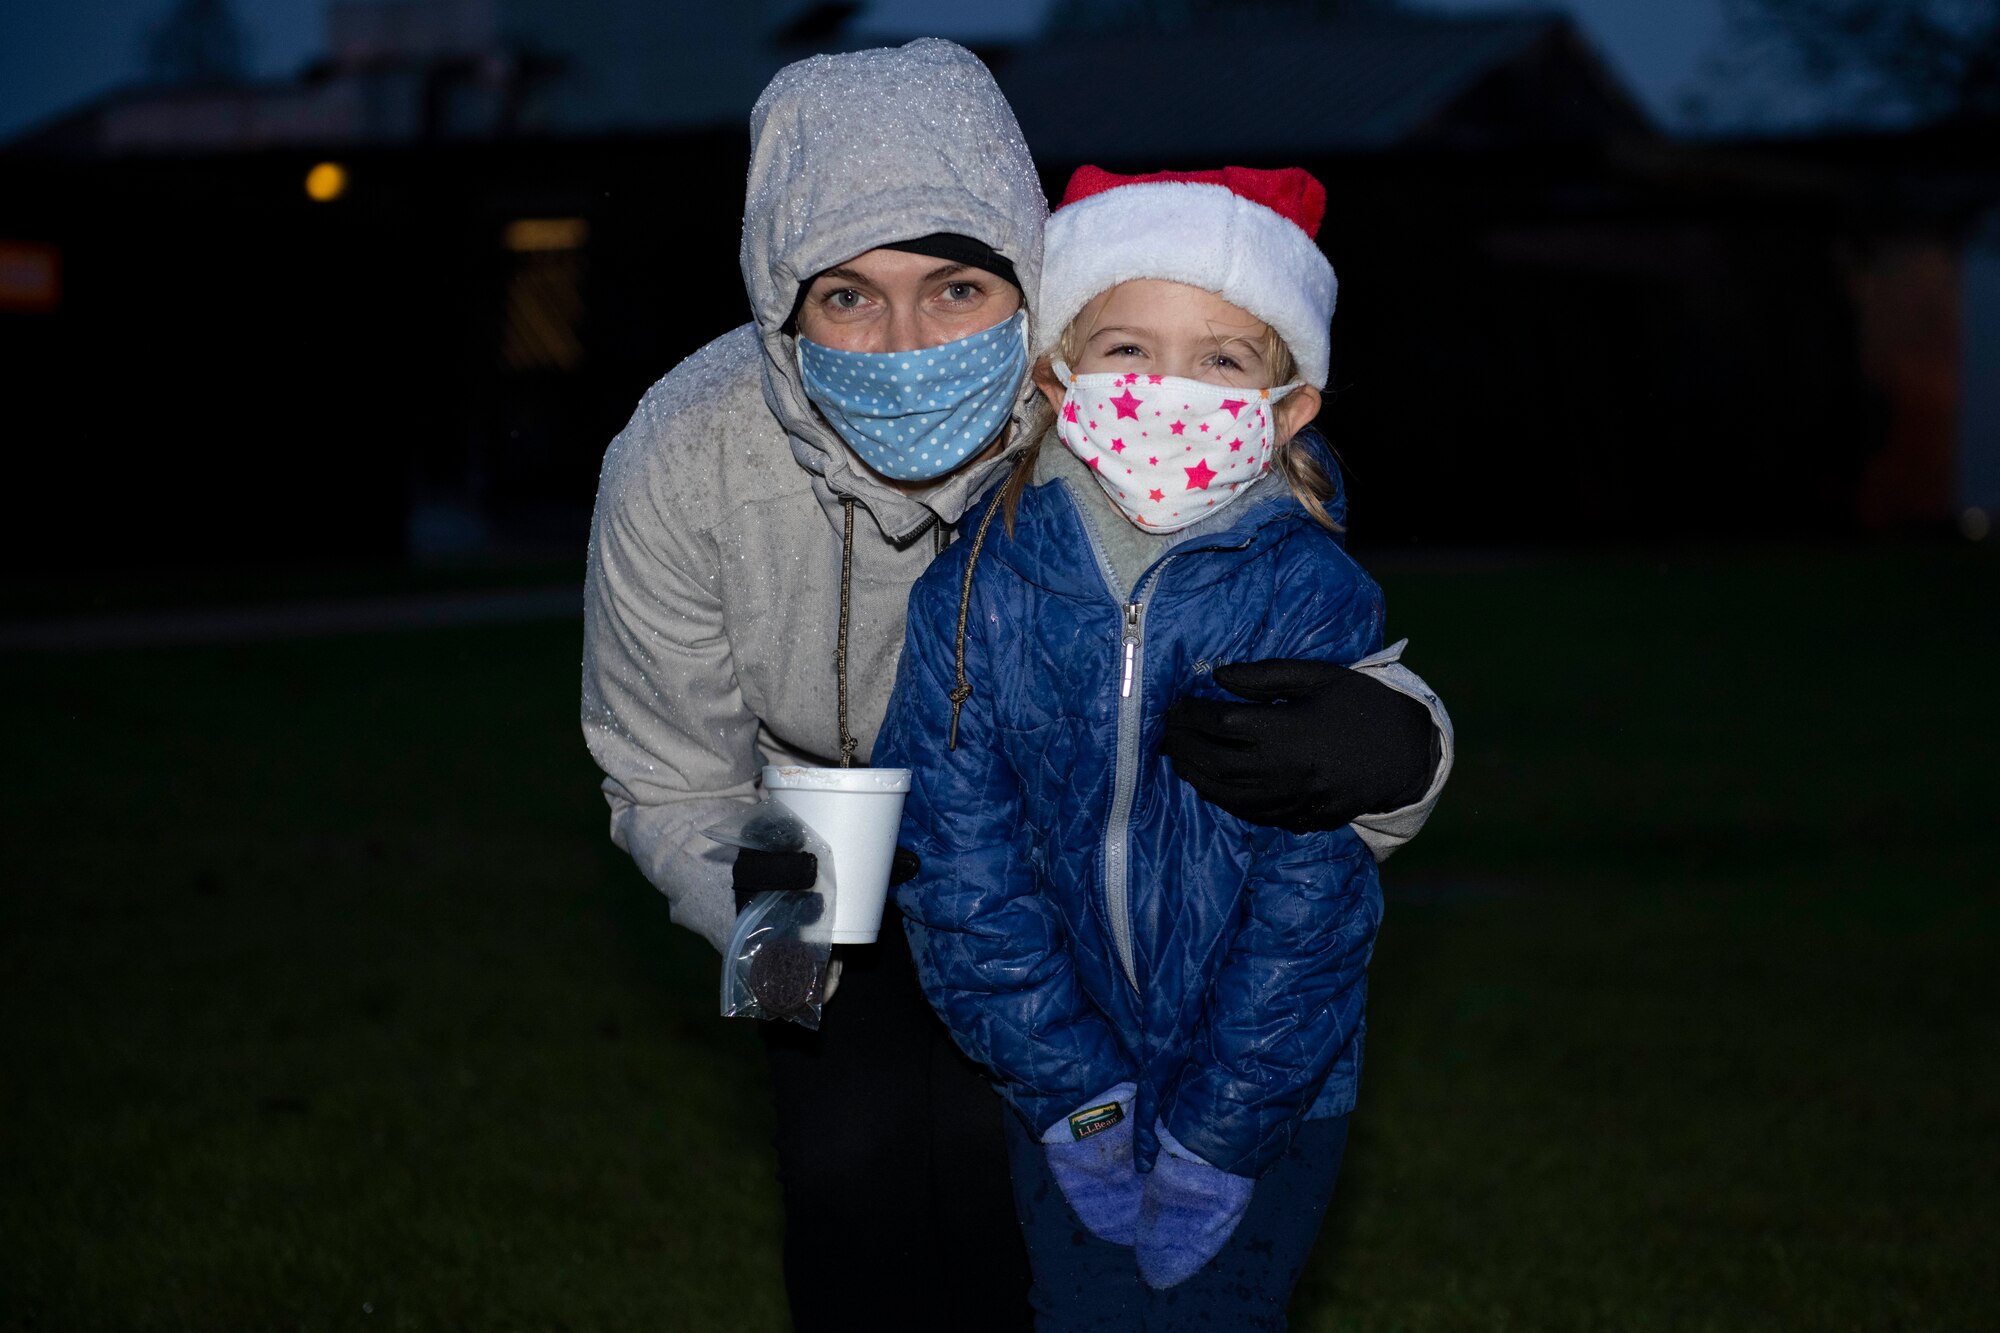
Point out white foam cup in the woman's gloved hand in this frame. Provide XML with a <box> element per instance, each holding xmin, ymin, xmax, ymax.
<box><xmin>764</xmin><ymin>765</ymin><xmax>910</xmax><ymax>945</ymax></box>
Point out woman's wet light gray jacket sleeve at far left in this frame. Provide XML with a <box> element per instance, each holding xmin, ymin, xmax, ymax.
<box><xmin>582</xmin><ymin>422</ymin><xmax>758</xmax><ymax>951</ymax></box>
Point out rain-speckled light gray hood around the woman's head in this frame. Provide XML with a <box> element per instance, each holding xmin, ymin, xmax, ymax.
<box><xmin>742</xmin><ymin>38</ymin><xmax>1048</xmax><ymax>544</ymax></box>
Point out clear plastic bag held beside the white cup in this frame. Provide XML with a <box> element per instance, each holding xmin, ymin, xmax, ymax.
<box><xmin>702</xmin><ymin>801</ymin><xmax>834</xmax><ymax>1031</ymax></box>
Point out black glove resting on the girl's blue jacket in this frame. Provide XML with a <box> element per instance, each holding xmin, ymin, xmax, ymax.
<box><xmin>1160</xmin><ymin>658</ymin><xmax>1442</xmax><ymax>833</ymax></box>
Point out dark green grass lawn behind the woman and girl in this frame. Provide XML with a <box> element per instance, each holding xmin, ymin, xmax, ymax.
<box><xmin>0</xmin><ymin>550</ymin><xmax>2000</xmax><ymax>1333</ymax></box>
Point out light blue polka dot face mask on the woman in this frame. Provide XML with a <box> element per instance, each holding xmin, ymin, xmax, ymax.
<box><xmin>798</xmin><ymin>310</ymin><xmax>1028</xmax><ymax>480</ymax></box>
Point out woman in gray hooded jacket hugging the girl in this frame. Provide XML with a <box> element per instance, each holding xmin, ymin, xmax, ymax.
<box><xmin>582</xmin><ymin>40</ymin><xmax>1450</xmax><ymax>1329</ymax></box>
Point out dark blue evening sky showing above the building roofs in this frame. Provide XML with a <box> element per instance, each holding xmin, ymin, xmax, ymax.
<box><xmin>0</xmin><ymin>0</ymin><xmax>1722</xmax><ymax>138</ymax></box>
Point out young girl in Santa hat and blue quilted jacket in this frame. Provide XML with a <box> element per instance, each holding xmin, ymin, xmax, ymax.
<box><xmin>874</xmin><ymin>166</ymin><xmax>1394</xmax><ymax>1329</ymax></box>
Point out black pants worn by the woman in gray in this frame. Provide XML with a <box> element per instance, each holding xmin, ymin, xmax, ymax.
<box><xmin>758</xmin><ymin>905</ymin><xmax>1032</xmax><ymax>1333</ymax></box>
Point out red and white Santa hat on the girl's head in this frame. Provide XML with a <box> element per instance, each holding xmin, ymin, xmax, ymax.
<box><xmin>1034</xmin><ymin>166</ymin><xmax>1338</xmax><ymax>388</ymax></box>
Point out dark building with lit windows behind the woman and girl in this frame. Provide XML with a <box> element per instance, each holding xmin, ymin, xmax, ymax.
<box><xmin>0</xmin><ymin>0</ymin><xmax>2000</xmax><ymax>566</ymax></box>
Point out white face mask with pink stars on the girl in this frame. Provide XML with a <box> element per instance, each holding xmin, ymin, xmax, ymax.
<box><xmin>1054</xmin><ymin>360</ymin><xmax>1298</xmax><ymax>532</ymax></box>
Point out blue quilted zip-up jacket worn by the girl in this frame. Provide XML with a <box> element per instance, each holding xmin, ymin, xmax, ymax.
<box><xmin>874</xmin><ymin>456</ymin><xmax>1382</xmax><ymax>1177</ymax></box>
